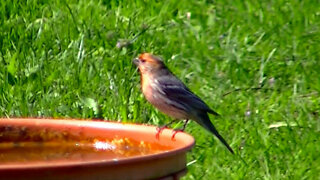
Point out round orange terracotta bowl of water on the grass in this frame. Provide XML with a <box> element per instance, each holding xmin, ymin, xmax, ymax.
<box><xmin>0</xmin><ymin>118</ymin><xmax>195</xmax><ymax>180</ymax></box>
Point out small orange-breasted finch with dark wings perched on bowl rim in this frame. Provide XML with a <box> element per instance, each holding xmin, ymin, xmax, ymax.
<box><xmin>133</xmin><ymin>53</ymin><xmax>234</xmax><ymax>154</ymax></box>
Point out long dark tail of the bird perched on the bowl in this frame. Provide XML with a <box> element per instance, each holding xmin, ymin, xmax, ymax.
<box><xmin>196</xmin><ymin>113</ymin><xmax>234</xmax><ymax>154</ymax></box>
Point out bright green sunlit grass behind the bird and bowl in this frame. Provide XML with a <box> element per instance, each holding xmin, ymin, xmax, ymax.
<box><xmin>0</xmin><ymin>0</ymin><xmax>320</xmax><ymax>179</ymax></box>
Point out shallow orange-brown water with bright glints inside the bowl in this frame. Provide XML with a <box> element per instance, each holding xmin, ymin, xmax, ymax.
<box><xmin>0</xmin><ymin>127</ymin><xmax>172</xmax><ymax>165</ymax></box>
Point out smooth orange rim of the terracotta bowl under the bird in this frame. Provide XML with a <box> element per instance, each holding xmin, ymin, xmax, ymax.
<box><xmin>0</xmin><ymin>118</ymin><xmax>195</xmax><ymax>171</ymax></box>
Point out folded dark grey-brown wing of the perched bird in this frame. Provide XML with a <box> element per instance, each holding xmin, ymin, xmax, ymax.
<box><xmin>157</xmin><ymin>76</ymin><xmax>218</xmax><ymax>115</ymax></box>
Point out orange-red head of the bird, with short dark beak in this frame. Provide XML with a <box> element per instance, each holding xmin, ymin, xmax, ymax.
<box><xmin>133</xmin><ymin>53</ymin><xmax>165</xmax><ymax>73</ymax></box>
